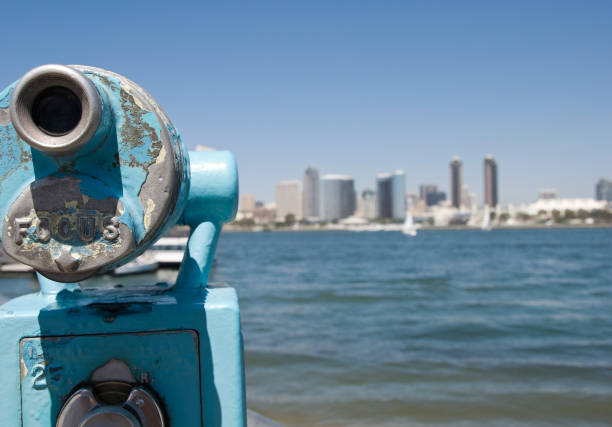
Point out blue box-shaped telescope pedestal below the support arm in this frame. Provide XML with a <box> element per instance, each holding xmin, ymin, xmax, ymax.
<box><xmin>0</xmin><ymin>286</ymin><xmax>246</xmax><ymax>427</ymax></box>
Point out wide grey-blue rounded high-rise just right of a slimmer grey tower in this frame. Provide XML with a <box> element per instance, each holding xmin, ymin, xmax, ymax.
<box><xmin>321</xmin><ymin>175</ymin><xmax>355</xmax><ymax>221</ymax></box>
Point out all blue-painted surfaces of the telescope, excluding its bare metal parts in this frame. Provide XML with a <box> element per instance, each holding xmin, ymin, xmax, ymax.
<box><xmin>0</xmin><ymin>65</ymin><xmax>246</xmax><ymax>427</ymax></box>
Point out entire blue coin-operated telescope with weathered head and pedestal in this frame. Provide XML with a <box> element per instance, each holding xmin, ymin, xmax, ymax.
<box><xmin>0</xmin><ymin>65</ymin><xmax>246</xmax><ymax>427</ymax></box>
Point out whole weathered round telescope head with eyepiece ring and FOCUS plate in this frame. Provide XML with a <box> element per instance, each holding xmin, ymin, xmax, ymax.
<box><xmin>0</xmin><ymin>65</ymin><xmax>189</xmax><ymax>282</ymax></box>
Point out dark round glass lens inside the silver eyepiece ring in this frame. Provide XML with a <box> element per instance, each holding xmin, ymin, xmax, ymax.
<box><xmin>31</xmin><ymin>86</ymin><xmax>82</xmax><ymax>136</ymax></box>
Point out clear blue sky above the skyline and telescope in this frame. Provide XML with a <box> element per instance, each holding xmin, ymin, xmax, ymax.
<box><xmin>0</xmin><ymin>0</ymin><xmax>612</xmax><ymax>203</ymax></box>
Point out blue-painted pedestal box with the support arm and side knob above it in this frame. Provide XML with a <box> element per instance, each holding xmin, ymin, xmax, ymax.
<box><xmin>0</xmin><ymin>152</ymin><xmax>246</xmax><ymax>426</ymax></box>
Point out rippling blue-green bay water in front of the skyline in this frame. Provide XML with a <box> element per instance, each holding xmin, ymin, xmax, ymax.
<box><xmin>0</xmin><ymin>229</ymin><xmax>612</xmax><ymax>426</ymax></box>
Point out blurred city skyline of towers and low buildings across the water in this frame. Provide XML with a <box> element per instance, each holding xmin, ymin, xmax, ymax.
<box><xmin>237</xmin><ymin>155</ymin><xmax>612</xmax><ymax>227</ymax></box>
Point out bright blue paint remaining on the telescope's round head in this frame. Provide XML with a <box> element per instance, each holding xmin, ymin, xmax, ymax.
<box><xmin>0</xmin><ymin>67</ymin><xmax>186</xmax><ymax>241</ymax></box>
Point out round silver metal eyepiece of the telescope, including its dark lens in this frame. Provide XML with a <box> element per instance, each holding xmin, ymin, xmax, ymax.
<box><xmin>10</xmin><ymin>64</ymin><xmax>102</xmax><ymax>156</ymax></box>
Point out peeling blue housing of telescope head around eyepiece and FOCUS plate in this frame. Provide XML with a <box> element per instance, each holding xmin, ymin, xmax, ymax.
<box><xmin>0</xmin><ymin>66</ymin><xmax>189</xmax><ymax>278</ymax></box>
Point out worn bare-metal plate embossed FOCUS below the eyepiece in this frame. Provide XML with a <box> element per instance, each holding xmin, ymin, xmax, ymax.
<box><xmin>2</xmin><ymin>176</ymin><xmax>135</xmax><ymax>281</ymax></box>
